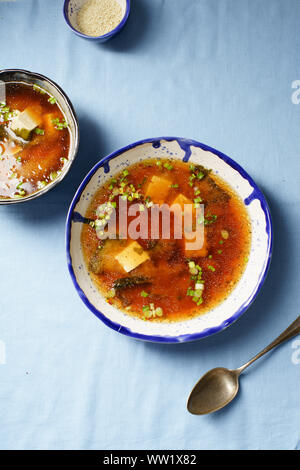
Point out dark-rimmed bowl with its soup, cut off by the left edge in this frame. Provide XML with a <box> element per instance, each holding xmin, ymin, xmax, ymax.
<box><xmin>0</xmin><ymin>69</ymin><xmax>79</xmax><ymax>204</ymax></box>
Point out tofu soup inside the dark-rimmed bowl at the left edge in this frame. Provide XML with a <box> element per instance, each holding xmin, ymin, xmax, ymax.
<box><xmin>0</xmin><ymin>82</ymin><xmax>70</xmax><ymax>199</ymax></box>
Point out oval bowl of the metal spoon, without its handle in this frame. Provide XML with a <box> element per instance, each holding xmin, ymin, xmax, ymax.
<box><xmin>187</xmin><ymin>367</ymin><xmax>240</xmax><ymax>415</ymax></box>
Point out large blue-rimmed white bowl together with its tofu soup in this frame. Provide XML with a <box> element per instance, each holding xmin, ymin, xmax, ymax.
<box><xmin>66</xmin><ymin>137</ymin><xmax>273</xmax><ymax>343</ymax></box>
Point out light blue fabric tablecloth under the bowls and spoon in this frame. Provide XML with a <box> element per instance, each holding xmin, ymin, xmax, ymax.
<box><xmin>0</xmin><ymin>0</ymin><xmax>300</xmax><ymax>449</ymax></box>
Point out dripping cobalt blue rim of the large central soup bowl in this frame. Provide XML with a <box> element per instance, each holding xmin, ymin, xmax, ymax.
<box><xmin>66</xmin><ymin>137</ymin><xmax>273</xmax><ymax>344</ymax></box>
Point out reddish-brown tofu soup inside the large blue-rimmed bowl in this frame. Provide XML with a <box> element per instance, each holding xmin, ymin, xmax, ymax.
<box><xmin>81</xmin><ymin>159</ymin><xmax>251</xmax><ymax>321</ymax></box>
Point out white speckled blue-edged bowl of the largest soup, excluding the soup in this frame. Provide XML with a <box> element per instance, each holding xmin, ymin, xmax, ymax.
<box><xmin>66</xmin><ymin>137</ymin><xmax>273</xmax><ymax>343</ymax></box>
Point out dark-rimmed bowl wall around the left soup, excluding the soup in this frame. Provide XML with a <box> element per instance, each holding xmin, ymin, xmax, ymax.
<box><xmin>0</xmin><ymin>69</ymin><xmax>79</xmax><ymax>205</ymax></box>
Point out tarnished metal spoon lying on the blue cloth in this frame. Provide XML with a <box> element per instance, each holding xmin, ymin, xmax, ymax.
<box><xmin>187</xmin><ymin>316</ymin><xmax>300</xmax><ymax>415</ymax></box>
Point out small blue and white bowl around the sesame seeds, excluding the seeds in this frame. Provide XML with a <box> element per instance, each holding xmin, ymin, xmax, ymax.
<box><xmin>63</xmin><ymin>0</ymin><xmax>130</xmax><ymax>42</ymax></box>
